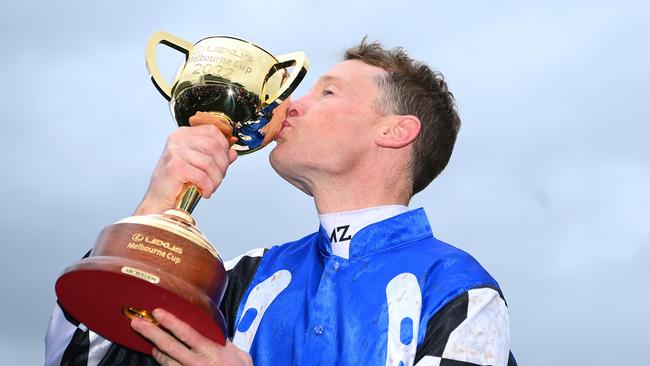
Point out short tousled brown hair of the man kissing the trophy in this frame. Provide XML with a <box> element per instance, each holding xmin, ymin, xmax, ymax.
<box><xmin>343</xmin><ymin>37</ymin><xmax>460</xmax><ymax>195</ymax></box>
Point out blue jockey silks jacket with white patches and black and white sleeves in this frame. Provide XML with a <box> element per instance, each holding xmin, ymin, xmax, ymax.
<box><xmin>46</xmin><ymin>209</ymin><xmax>516</xmax><ymax>366</ymax></box>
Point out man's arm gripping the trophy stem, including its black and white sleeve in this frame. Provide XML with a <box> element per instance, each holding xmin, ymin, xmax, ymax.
<box><xmin>45</xmin><ymin>114</ymin><xmax>237</xmax><ymax>366</ymax></box>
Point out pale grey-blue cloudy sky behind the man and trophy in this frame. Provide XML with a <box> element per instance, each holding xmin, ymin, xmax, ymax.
<box><xmin>0</xmin><ymin>1</ymin><xmax>650</xmax><ymax>366</ymax></box>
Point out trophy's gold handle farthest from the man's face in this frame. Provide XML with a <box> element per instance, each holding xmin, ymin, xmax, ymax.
<box><xmin>146</xmin><ymin>31</ymin><xmax>194</xmax><ymax>101</ymax></box>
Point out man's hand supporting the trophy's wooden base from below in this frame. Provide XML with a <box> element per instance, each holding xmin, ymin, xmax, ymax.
<box><xmin>131</xmin><ymin>309</ymin><xmax>253</xmax><ymax>366</ymax></box>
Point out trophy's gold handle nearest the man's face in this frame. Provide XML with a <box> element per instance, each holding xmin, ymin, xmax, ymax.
<box><xmin>262</xmin><ymin>51</ymin><xmax>309</xmax><ymax>114</ymax></box>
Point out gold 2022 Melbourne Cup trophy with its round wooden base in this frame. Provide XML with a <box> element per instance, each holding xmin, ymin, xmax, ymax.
<box><xmin>55</xmin><ymin>32</ymin><xmax>309</xmax><ymax>354</ymax></box>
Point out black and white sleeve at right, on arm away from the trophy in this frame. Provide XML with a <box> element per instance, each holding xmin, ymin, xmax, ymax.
<box><xmin>415</xmin><ymin>287</ymin><xmax>517</xmax><ymax>366</ymax></box>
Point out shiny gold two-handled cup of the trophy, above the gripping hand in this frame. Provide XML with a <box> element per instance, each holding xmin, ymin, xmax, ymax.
<box><xmin>147</xmin><ymin>32</ymin><xmax>309</xmax><ymax>154</ymax></box>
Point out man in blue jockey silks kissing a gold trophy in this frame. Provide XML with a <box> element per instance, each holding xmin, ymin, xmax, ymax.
<box><xmin>46</xmin><ymin>40</ymin><xmax>516</xmax><ymax>366</ymax></box>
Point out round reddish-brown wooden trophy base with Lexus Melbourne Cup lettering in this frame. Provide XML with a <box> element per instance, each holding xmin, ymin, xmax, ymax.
<box><xmin>56</xmin><ymin>211</ymin><xmax>228</xmax><ymax>355</ymax></box>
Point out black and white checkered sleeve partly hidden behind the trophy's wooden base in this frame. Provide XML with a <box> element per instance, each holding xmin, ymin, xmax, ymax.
<box><xmin>45</xmin><ymin>249</ymin><xmax>266</xmax><ymax>366</ymax></box>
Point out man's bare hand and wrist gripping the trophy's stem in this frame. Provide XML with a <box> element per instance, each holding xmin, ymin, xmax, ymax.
<box><xmin>135</xmin><ymin>112</ymin><xmax>237</xmax><ymax>215</ymax></box>
